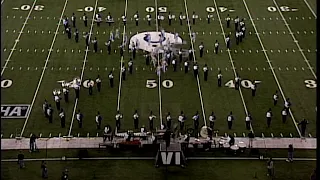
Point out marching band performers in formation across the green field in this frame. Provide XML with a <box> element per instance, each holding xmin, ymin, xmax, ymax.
<box><xmin>38</xmin><ymin>11</ymin><xmax>308</xmax><ymax>136</ymax></box>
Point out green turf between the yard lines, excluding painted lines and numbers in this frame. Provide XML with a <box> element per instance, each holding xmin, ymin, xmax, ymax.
<box><xmin>1</xmin><ymin>0</ymin><xmax>316</xmax><ymax>137</ymax></box>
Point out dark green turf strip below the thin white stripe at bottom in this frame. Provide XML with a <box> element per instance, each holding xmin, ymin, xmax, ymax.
<box><xmin>1</xmin><ymin>160</ymin><xmax>315</xmax><ymax>180</ymax></box>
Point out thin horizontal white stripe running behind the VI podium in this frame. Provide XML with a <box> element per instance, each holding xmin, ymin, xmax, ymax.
<box><xmin>1</xmin><ymin>156</ymin><xmax>317</xmax><ymax>162</ymax></box>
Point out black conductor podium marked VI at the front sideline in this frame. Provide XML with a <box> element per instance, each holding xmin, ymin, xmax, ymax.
<box><xmin>156</xmin><ymin>142</ymin><xmax>186</xmax><ymax>167</ymax></box>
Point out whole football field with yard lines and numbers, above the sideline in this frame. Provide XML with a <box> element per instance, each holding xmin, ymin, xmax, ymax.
<box><xmin>1</xmin><ymin>0</ymin><xmax>317</xmax><ymax>138</ymax></box>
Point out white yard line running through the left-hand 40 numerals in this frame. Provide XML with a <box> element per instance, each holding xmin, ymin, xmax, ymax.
<box><xmin>68</xmin><ymin>0</ymin><xmax>98</xmax><ymax>136</ymax></box>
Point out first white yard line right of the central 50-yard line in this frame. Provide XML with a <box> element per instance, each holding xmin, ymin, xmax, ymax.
<box><xmin>184</xmin><ymin>0</ymin><xmax>207</xmax><ymax>126</ymax></box>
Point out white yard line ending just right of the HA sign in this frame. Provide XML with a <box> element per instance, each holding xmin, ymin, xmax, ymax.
<box><xmin>20</xmin><ymin>0</ymin><xmax>68</xmax><ymax>137</ymax></box>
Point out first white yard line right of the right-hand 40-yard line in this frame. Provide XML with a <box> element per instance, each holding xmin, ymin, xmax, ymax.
<box><xmin>242</xmin><ymin>0</ymin><xmax>301</xmax><ymax>137</ymax></box>
